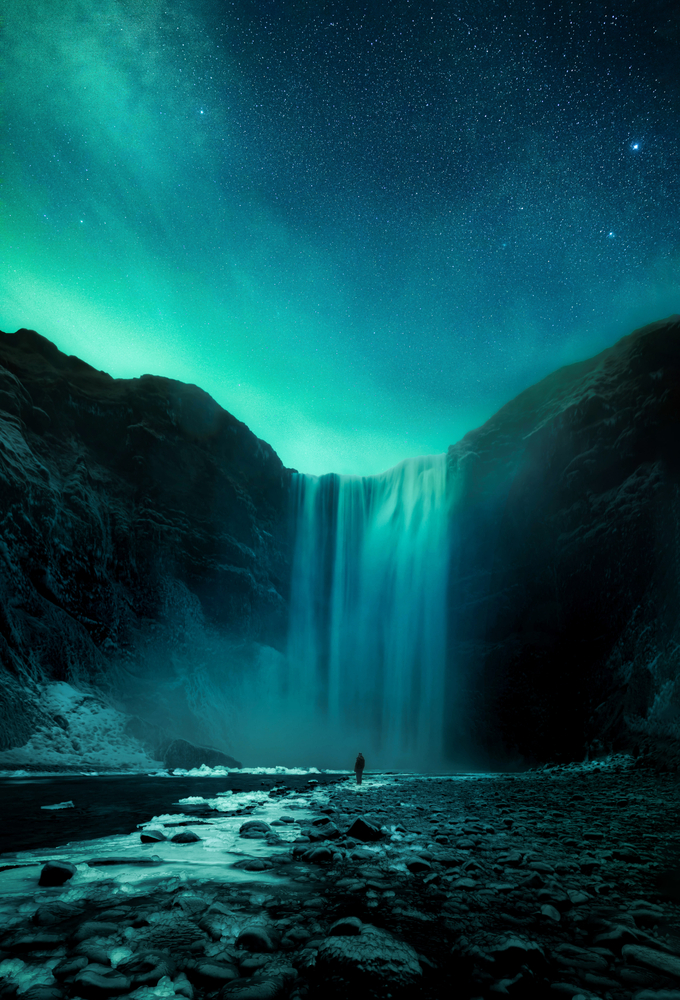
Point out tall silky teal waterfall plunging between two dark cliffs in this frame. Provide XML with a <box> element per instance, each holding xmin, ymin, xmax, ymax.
<box><xmin>286</xmin><ymin>455</ymin><xmax>448</xmax><ymax>769</ymax></box>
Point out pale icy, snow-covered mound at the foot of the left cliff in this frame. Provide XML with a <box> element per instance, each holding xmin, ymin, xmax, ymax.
<box><xmin>0</xmin><ymin>681</ymin><xmax>158</xmax><ymax>773</ymax></box>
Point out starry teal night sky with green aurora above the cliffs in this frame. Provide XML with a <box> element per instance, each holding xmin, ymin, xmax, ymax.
<box><xmin>0</xmin><ymin>0</ymin><xmax>680</xmax><ymax>474</ymax></box>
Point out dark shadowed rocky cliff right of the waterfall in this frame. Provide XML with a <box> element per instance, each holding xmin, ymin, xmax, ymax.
<box><xmin>448</xmin><ymin>316</ymin><xmax>680</xmax><ymax>760</ymax></box>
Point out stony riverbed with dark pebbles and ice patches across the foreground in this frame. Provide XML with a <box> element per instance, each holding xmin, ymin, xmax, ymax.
<box><xmin>0</xmin><ymin>757</ymin><xmax>680</xmax><ymax>1000</ymax></box>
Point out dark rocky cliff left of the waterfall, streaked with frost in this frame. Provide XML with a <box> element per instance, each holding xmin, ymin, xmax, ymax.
<box><xmin>0</xmin><ymin>330</ymin><xmax>289</xmax><ymax>749</ymax></box>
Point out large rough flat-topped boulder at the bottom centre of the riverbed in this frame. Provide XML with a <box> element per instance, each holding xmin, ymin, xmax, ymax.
<box><xmin>316</xmin><ymin>924</ymin><xmax>422</xmax><ymax>988</ymax></box>
